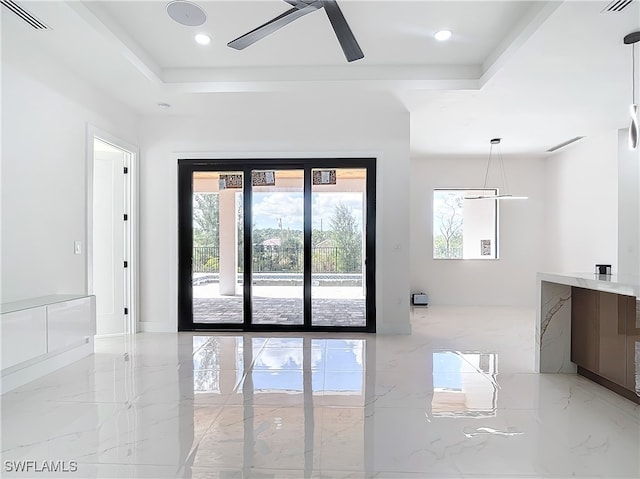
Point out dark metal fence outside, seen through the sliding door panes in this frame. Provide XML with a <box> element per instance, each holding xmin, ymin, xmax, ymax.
<box><xmin>192</xmin><ymin>246</ymin><xmax>362</xmax><ymax>273</ymax></box>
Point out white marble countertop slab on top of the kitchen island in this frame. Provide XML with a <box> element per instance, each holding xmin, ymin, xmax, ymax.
<box><xmin>537</xmin><ymin>273</ymin><xmax>640</xmax><ymax>299</ymax></box>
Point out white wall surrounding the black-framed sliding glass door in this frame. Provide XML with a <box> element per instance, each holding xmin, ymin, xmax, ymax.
<box><xmin>140</xmin><ymin>92</ymin><xmax>410</xmax><ymax>333</ymax></box>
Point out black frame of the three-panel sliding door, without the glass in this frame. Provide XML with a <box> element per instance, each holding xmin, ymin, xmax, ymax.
<box><xmin>178</xmin><ymin>158</ymin><xmax>376</xmax><ymax>332</ymax></box>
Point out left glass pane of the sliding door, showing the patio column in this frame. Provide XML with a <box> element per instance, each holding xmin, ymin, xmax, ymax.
<box><xmin>191</xmin><ymin>171</ymin><xmax>244</xmax><ymax>324</ymax></box>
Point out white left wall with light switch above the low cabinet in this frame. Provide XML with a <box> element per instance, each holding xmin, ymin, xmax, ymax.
<box><xmin>1</xmin><ymin>34</ymin><xmax>136</xmax><ymax>302</ymax></box>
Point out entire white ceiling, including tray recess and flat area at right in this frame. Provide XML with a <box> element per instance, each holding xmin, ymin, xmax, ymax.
<box><xmin>2</xmin><ymin>0</ymin><xmax>640</xmax><ymax>156</ymax></box>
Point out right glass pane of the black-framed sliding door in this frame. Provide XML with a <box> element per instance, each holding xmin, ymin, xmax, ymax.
<box><xmin>311</xmin><ymin>168</ymin><xmax>367</xmax><ymax>327</ymax></box>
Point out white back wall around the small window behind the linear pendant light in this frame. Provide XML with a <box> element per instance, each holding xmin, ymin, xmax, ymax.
<box><xmin>410</xmin><ymin>157</ymin><xmax>545</xmax><ymax>307</ymax></box>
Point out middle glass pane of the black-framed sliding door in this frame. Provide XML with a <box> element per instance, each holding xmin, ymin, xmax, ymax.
<box><xmin>251</xmin><ymin>169</ymin><xmax>304</xmax><ymax>325</ymax></box>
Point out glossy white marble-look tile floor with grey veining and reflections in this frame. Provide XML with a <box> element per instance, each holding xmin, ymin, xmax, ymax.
<box><xmin>1</xmin><ymin>307</ymin><xmax>640</xmax><ymax>479</ymax></box>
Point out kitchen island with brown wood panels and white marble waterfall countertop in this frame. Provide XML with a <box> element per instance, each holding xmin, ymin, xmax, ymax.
<box><xmin>535</xmin><ymin>273</ymin><xmax>640</xmax><ymax>404</ymax></box>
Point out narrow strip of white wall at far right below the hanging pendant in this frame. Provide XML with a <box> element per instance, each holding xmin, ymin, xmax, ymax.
<box><xmin>618</xmin><ymin>129</ymin><xmax>640</xmax><ymax>276</ymax></box>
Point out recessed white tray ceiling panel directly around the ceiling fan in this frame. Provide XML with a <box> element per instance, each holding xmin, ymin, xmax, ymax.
<box><xmin>87</xmin><ymin>0</ymin><xmax>532</xmax><ymax>70</ymax></box>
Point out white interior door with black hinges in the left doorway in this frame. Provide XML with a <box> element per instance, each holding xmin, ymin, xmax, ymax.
<box><xmin>93</xmin><ymin>139</ymin><xmax>126</xmax><ymax>335</ymax></box>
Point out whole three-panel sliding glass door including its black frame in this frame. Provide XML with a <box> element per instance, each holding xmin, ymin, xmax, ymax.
<box><xmin>178</xmin><ymin>159</ymin><xmax>375</xmax><ymax>331</ymax></box>
